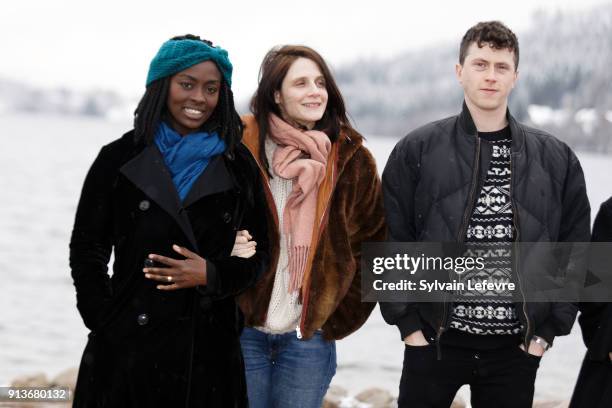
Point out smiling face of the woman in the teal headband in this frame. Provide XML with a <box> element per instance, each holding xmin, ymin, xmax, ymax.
<box><xmin>166</xmin><ymin>61</ymin><xmax>222</xmax><ymax>136</ymax></box>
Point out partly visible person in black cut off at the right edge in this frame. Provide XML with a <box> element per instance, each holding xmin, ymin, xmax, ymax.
<box><xmin>570</xmin><ymin>198</ymin><xmax>612</xmax><ymax>408</ymax></box>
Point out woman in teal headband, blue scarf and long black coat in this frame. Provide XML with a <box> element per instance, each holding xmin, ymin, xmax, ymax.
<box><xmin>70</xmin><ymin>35</ymin><xmax>268</xmax><ymax>408</ymax></box>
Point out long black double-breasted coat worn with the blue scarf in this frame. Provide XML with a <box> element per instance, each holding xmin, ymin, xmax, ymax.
<box><xmin>70</xmin><ymin>132</ymin><xmax>269</xmax><ymax>407</ymax></box>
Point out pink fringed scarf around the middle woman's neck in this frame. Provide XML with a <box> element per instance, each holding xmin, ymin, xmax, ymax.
<box><xmin>268</xmin><ymin>114</ymin><xmax>331</xmax><ymax>293</ymax></box>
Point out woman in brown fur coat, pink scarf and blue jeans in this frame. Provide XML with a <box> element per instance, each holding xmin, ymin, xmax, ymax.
<box><xmin>239</xmin><ymin>46</ymin><xmax>385</xmax><ymax>408</ymax></box>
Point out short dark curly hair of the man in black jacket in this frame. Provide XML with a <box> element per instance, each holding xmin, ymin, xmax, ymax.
<box><xmin>459</xmin><ymin>21</ymin><xmax>519</xmax><ymax>69</ymax></box>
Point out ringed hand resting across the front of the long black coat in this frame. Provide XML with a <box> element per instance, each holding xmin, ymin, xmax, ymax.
<box><xmin>143</xmin><ymin>245</ymin><xmax>207</xmax><ymax>290</ymax></box>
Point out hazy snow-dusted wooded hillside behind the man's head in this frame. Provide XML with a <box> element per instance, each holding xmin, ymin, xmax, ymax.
<box><xmin>336</xmin><ymin>4</ymin><xmax>612</xmax><ymax>153</ymax></box>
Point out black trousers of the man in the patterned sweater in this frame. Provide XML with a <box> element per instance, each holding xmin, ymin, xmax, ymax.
<box><xmin>398</xmin><ymin>345</ymin><xmax>540</xmax><ymax>408</ymax></box>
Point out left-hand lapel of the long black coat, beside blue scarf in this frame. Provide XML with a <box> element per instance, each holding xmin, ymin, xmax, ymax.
<box><xmin>119</xmin><ymin>145</ymin><xmax>198</xmax><ymax>251</ymax></box>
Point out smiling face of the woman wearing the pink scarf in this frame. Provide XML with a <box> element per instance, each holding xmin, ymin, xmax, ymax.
<box><xmin>274</xmin><ymin>57</ymin><xmax>327</xmax><ymax>129</ymax></box>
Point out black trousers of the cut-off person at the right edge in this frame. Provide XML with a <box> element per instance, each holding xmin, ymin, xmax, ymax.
<box><xmin>570</xmin><ymin>357</ymin><xmax>612</xmax><ymax>408</ymax></box>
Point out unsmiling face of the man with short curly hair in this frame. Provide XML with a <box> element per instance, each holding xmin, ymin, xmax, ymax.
<box><xmin>455</xmin><ymin>42</ymin><xmax>518</xmax><ymax>113</ymax></box>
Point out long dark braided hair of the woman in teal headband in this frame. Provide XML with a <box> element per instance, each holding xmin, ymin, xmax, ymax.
<box><xmin>134</xmin><ymin>34</ymin><xmax>243</xmax><ymax>158</ymax></box>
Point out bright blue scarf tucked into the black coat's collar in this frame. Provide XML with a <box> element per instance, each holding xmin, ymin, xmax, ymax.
<box><xmin>155</xmin><ymin>122</ymin><xmax>226</xmax><ymax>201</ymax></box>
